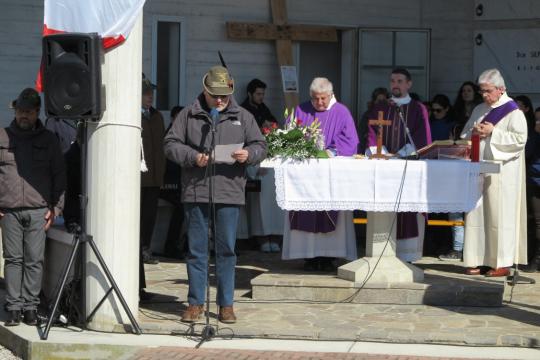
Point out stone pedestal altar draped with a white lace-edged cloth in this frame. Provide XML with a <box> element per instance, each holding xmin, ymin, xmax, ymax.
<box><xmin>263</xmin><ymin>157</ymin><xmax>498</xmax><ymax>286</ymax></box>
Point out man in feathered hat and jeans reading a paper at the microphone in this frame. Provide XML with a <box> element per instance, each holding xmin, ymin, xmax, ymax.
<box><xmin>164</xmin><ymin>66</ymin><xmax>266</xmax><ymax>323</ymax></box>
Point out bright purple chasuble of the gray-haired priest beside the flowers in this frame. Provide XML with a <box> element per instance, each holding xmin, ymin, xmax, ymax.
<box><xmin>289</xmin><ymin>101</ymin><xmax>358</xmax><ymax>233</ymax></box>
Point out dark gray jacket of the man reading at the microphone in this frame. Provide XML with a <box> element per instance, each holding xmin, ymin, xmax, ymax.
<box><xmin>164</xmin><ymin>94</ymin><xmax>266</xmax><ymax>205</ymax></box>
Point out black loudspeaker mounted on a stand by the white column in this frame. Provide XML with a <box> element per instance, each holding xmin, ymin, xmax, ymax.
<box><xmin>42</xmin><ymin>33</ymin><xmax>105</xmax><ymax>120</ymax></box>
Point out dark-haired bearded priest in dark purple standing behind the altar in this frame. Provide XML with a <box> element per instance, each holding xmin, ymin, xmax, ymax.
<box><xmin>368</xmin><ymin>68</ymin><xmax>431</xmax><ymax>262</ymax></box>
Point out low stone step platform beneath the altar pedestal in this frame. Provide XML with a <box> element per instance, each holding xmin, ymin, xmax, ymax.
<box><xmin>251</xmin><ymin>260</ymin><xmax>505</xmax><ymax>307</ymax></box>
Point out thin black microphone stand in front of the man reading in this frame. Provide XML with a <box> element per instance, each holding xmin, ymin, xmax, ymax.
<box><xmin>195</xmin><ymin>108</ymin><xmax>219</xmax><ymax>349</ymax></box>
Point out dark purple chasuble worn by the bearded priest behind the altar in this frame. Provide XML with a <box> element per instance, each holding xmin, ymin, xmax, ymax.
<box><xmin>368</xmin><ymin>100</ymin><xmax>431</xmax><ymax>240</ymax></box>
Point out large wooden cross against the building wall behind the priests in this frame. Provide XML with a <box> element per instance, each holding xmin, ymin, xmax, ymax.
<box><xmin>227</xmin><ymin>0</ymin><xmax>338</xmax><ymax>109</ymax></box>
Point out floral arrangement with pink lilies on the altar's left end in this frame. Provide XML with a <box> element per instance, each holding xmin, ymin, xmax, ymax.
<box><xmin>262</xmin><ymin>110</ymin><xmax>328</xmax><ymax>160</ymax></box>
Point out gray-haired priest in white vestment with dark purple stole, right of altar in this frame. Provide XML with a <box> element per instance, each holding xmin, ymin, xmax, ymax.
<box><xmin>461</xmin><ymin>69</ymin><xmax>527</xmax><ymax>277</ymax></box>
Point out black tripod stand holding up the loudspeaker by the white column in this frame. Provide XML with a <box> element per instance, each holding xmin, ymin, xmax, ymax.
<box><xmin>41</xmin><ymin>120</ymin><xmax>142</xmax><ymax>340</ymax></box>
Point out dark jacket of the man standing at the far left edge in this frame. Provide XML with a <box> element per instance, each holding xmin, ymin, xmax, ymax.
<box><xmin>0</xmin><ymin>120</ymin><xmax>66</xmax><ymax>215</ymax></box>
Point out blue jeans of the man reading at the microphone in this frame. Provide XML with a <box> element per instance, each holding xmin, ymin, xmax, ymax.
<box><xmin>184</xmin><ymin>203</ymin><xmax>239</xmax><ymax>306</ymax></box>
